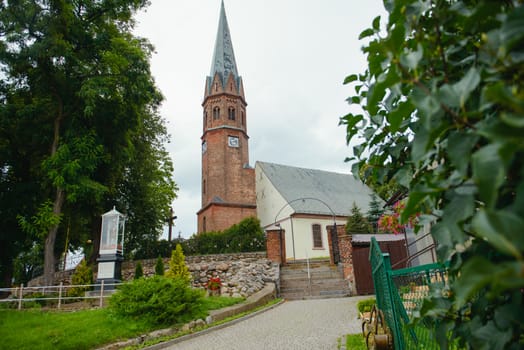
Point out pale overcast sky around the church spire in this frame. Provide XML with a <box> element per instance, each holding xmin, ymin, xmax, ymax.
<box><xmin>135</xmin><ymin>0</ymin><xmax>385</xmax><ymax>238</ymax></box>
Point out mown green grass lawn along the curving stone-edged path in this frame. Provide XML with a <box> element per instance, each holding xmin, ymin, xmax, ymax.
<box><xmin>0</xmin><ymin>297</ymin><xmax>243</xmax><ymax>349</ymax></box>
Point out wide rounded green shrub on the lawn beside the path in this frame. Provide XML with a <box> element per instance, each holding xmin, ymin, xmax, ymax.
<box><xmin>109</xmin><ymin>276</ymin><xmax>205</xmax><ymax>325</ymax></box>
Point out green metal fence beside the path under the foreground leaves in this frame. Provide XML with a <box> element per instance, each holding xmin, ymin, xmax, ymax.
<box><xmin>369</xmin><ymin>237</ymin><xmax>447</xmax><ymax>350</ymax></box>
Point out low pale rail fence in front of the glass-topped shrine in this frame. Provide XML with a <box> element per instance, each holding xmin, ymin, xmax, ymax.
<box><xmin>0</xmin><ymin>281</ymin><xmax>122</xmax><ymax>310</ymax></box>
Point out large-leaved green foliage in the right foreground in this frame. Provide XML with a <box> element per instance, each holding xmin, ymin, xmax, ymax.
<box><xmin>341</xmin><ymin>0</ymin><xmax>524</xmax><ymax>349</ymax></box>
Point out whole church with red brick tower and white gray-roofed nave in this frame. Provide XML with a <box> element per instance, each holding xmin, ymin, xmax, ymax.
<box><xmin>197</xmin><ymin>1</ymin><xmax>380</xmax><ymax>258</ymax></box>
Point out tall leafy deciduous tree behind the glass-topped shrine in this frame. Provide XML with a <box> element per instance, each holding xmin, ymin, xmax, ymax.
<box><xmin>0</xmin><ymin>0</ymin><xmax>175</xmax><ymax>283</ymax></box>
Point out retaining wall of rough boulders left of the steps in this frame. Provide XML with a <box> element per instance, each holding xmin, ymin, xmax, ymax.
<box><xmin>122</xmin><ymin>252</ymin><xmax>280</xmax><ymax>297</ymax></box>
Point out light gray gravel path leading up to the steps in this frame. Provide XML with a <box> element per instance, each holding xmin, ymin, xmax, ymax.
<box><xmin>163</xmin><ymin>296</ymin><xmax>369</xmax><ymax>350</ymax></box>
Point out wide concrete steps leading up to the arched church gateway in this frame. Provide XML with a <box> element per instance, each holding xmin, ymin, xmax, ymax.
<box><xmin>280</xmin><ymin>260</ymin><xmax>350</xmax><ymax>300</ymax></box>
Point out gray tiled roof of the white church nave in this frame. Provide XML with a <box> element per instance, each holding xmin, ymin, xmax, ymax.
<box><xmin>257</xmin><ymin>162</ymin><xmax>381</xmax><ymax>216</ymax></box>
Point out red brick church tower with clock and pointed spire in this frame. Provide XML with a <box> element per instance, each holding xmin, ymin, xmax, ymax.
<box><xmin>197</xmin><ymin>1</ymin><xmax>256</xmax><ymax>232</ymax></box>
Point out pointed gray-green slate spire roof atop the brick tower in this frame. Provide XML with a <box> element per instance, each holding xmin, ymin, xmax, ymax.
<box><xmin>209</xmin><ymin>1</ymin><xmax>240</xmax><ymax>87</ymax></box>
